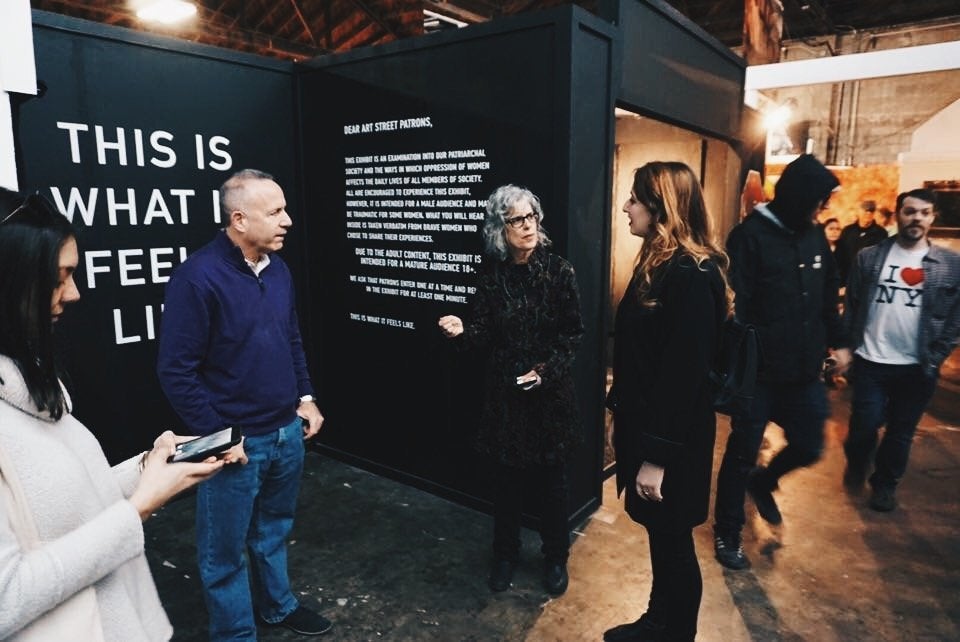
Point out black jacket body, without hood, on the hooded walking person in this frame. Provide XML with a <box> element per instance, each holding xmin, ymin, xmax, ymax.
<box><xmin>727</xmin><ymin>210</ymin><xmax>843</xmax><ymax>383</ymax></box>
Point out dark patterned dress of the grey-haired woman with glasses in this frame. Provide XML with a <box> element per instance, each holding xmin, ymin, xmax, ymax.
<box><xmin>462</xmin><ymin>248</ymin><xmax>583</xmax><ymax>468</ymax></box>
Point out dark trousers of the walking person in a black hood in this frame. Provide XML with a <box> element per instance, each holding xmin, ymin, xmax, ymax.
<box><xmin>713</xmin><ymin>380</ymin><xmax>828</xmax><ymax>534</ymax></box>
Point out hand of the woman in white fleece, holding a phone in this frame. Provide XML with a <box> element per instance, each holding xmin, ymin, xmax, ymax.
<box><xmin>129</xmin><ymin>430</ymin><xmax>226</xmax><ymax>521</ymax></box>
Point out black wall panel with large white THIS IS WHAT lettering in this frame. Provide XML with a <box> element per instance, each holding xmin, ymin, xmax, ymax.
<box><xmin>17</xmin><ymin>12</ymin><xmax>307</xmax><ymax>460</ymax></box>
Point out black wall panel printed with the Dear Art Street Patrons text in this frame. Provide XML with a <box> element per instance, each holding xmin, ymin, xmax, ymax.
<box><xmin>299</xmin><ymin>7</ymin><xmax>615</xmax><ymax>517</ymax></box>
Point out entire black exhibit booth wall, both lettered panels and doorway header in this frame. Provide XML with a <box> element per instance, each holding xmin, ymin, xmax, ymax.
<box><xmin>15</xmin><ymin>0</ymin><xmax>743</xmax><ymax>520</ymax></box>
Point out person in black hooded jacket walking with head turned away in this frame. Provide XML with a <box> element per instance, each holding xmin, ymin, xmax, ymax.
<box><xmin>713</xmin><ymin>154</ymin><xmax>843</xmax><ymax>569</ymax></box>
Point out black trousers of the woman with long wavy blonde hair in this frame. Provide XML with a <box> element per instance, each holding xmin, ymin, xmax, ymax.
<box><xmin>647</xmin><ymin>528</ymin><xmax>703</xmax><ymax>641</ymax></box>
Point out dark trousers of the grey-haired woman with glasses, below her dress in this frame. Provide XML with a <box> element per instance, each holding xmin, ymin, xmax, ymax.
<box><xmin>493</xmin><ymin>464</ymin><xmax>570</xmax><ymax>563</ymax></box>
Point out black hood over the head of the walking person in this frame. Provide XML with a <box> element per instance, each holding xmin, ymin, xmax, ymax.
<box><xmin>769</xmin><ymin>154</ymin><xmax>840</xmax><ymax>232</ymax></box>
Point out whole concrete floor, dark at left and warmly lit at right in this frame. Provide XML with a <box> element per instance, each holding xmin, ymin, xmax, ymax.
<box><xmin>147</xmin><ymin>382</ymin><xmax>960</xmax><ymax>642</ymax></box>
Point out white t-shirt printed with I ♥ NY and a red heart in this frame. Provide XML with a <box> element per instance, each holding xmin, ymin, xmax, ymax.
<box><xmin>856</xmin><ymin>243</ymin><xmax>930</xmax><ymax>365</ymax></box>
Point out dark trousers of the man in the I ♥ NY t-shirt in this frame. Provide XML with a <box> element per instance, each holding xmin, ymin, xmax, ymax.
<box><xmin>843</xmin><ymin>357</ymin><xmax>937</xmax><ymax>488</ymax></box>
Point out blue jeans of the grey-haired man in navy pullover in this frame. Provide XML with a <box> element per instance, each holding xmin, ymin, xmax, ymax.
<box><xmin>197</xmin><ymin>417</ymin><xmax>304</xmax><ymax>640</ymax></box>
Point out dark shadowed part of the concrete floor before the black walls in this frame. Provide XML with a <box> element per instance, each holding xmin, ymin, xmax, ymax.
<box><xmin>146</xmin><ymin>453</ymin><xmax>560</xmax><ymax>640</ymax></box>
